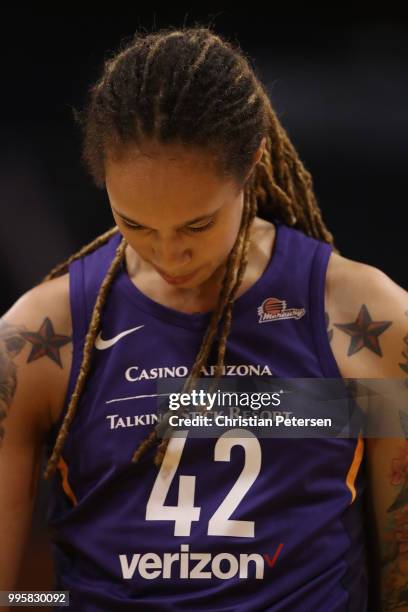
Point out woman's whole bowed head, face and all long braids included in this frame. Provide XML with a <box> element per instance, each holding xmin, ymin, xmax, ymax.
<box><xmin>44</xmin><ymin>26</ymin><xmax>333</xmax><ymax>477</ymax></box>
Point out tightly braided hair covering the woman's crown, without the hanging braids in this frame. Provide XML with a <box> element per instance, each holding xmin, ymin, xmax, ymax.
<box><xmin>77</xmin><ymin>27</ymin><xmax>269</xmax><ymax>195</ymax></box>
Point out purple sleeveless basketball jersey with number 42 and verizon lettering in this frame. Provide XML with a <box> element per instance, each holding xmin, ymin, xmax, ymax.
<box><xmin>48</xmin><ymin>220</ymin><xmax>367</xmax><ymax>612</ymax></box>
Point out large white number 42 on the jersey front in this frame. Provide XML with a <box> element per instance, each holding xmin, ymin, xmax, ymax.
<box><xmin>146</xmin><ymin>429</ymin><xmax>261</xmax><ymax>538</ymax></box>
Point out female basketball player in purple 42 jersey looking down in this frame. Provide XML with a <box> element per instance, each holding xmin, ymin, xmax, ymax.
<box><xmin>0</xmin><ymin>27</ymin><xmax>408</xmax><ymax>612</ymax></box>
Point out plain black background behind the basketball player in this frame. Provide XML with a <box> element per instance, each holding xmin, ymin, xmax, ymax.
<box><xmin>0</xmin><ymin>10</ymin><xmax>408</xmax><ymax>589</ymax></box>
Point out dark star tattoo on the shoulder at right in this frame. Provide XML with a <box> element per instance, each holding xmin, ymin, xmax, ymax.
<box><xmin>333</xmin><ymin>304</ymin><xmax>392</xmax><ymax>357</ymax></box>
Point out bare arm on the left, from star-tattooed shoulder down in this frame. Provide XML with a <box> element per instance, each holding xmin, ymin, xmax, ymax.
<box><xmin>0</xmin><ymin>279</ymin><xmax>71</xmax><ymax>590</ymax></box>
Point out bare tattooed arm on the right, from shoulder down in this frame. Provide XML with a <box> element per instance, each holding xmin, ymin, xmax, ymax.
<box><xmin>327</xmin><ymin>257</ymin><xmax>408</xmax><ymax>612</ymax></box>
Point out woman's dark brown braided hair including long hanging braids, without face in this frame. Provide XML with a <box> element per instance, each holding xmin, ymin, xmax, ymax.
<box><xmin>43</xmin><ymin>26</ymin><xmax>336</xmax><ymax>478</ymax></box>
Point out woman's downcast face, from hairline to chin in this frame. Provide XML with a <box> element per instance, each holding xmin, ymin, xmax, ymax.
<box><xmin>104</xmin><ymin>140</ymin><xmax>265</xmax><ymax>290</ymax></box>
